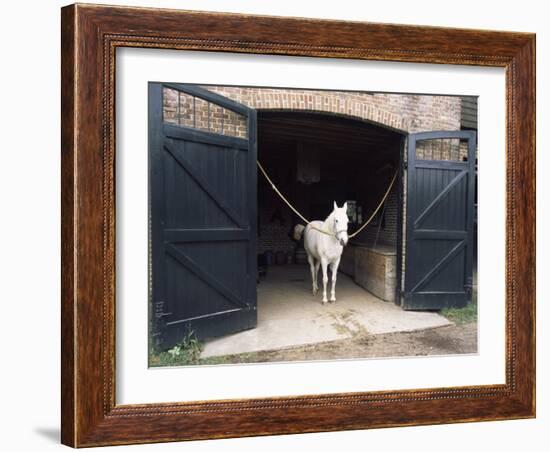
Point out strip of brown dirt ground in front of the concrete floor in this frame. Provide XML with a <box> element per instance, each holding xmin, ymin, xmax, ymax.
<box><xmin>204</xmin><ymin>322</ymin><xmax>477</xmax><ymax>364</ymax></box>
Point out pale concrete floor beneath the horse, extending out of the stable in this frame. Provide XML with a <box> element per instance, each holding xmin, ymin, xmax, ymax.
<box><xmin>201</xmin><ymin>265</ymin><xmax>450</xmax><ymax>357</ymax></box>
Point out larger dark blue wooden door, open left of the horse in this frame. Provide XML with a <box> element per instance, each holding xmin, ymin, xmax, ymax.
<box><xmin>149</xmin><ymin>83</ymin><xmax>257</xmax><ymax>347</ymax></box>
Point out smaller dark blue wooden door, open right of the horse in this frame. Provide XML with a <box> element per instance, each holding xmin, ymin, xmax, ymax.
<box><xmin>402</xmin><ymin>131</ymin><xmax>476</xmax><ymax>310</ymax></box>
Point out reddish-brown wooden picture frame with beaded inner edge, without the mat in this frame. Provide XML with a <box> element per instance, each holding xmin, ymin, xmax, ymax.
<box><xmin>61</xmin><ymin>4</ymin><xmax>535</xmax><ymax>447</ymax></box>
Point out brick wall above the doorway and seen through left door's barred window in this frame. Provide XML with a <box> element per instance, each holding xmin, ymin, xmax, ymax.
<box><xmin>164</xmin><ymin>86</ymin><xmax>461</xmax><ymax>136</ymax></box>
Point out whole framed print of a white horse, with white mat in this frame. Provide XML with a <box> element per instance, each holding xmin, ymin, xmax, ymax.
<box><xmin>62</xmin><ymin>4</ymin><xmax>535</xmax><ymax>447</ymax></box>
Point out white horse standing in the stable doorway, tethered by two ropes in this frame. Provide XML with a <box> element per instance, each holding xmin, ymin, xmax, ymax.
<box><xmin>294</xmin><ymin>201</ymin><xmax>348</xmax><ymax>303</ymax></box>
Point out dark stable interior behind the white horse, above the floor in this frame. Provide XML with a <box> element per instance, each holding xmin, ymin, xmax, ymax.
<box><xmin>257</xmin><ymin>110</ymin><xmax>403</xmax><ymax>306</ymax></box>
